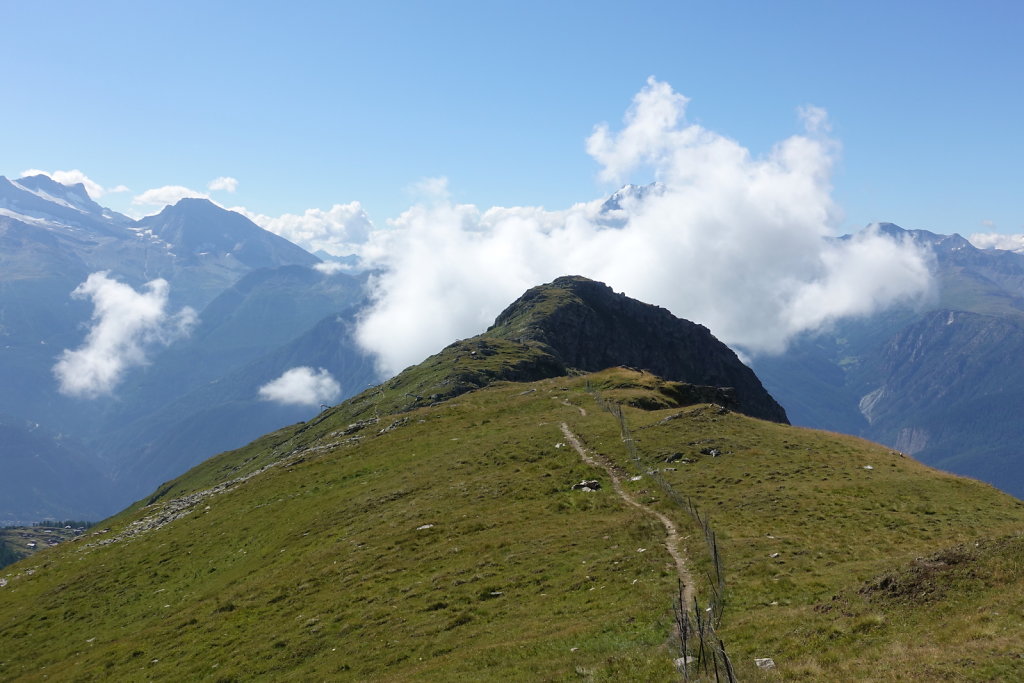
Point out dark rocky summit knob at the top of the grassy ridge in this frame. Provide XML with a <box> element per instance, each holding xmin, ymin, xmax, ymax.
<box><xmin>485</xmin><ymin>275</ymin><xmax>788</xmax><ymax>424</ymax></box>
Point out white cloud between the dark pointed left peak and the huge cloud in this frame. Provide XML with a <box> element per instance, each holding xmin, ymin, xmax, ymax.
<box><xmin>238</xmin><ymin>202</ymin><xmax>374</xmax><ymax>256</ymax></box>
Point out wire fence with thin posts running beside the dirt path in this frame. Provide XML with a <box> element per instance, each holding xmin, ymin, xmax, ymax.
<box><xmin>587</xmin><ymin>380</ymin><xmax>736</xmax><ymax>683</ymax></box>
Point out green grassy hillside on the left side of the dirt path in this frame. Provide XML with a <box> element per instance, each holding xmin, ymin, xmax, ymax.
<box><xmin>0</xmin><ymin>383</ymin><xmax>688</xmax><ymax>680</ymax></box>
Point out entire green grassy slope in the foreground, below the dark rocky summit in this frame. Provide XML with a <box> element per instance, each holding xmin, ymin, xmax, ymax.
<box><xmin>0</xmin><ymin>368</ymin><xmax>1024</xmax><ymax>681</ymax></box>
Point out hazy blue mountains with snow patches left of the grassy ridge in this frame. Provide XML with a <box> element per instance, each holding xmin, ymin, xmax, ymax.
<box><xmin>0</xmin><ymin>175</ymin><xmax>377</xmax><ymax>523</ymax></box>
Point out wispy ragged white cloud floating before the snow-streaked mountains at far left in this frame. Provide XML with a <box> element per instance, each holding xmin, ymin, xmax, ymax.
<box><xmin>53</xmin><ymin>271</ymin><xmax>198</xmax><ymax>398</ymax></box>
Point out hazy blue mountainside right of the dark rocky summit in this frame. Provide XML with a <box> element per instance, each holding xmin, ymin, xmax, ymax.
<box><xmin>752</xmin><ymin>223</ymin><xmax>1024</xmax><ymax>497</ymax></box>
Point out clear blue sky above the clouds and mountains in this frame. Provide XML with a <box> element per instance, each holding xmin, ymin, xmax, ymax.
<box><xmin>0</xmin><ymin>0</ymin><xmax>1024</xmax><ymax>234</ymax></box>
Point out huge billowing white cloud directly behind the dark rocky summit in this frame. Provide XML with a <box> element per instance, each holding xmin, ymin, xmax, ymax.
<box><xmin>356</xmin><ymin>78</ymin><xmax>932</xmax><ymax>374</ymax></box>
